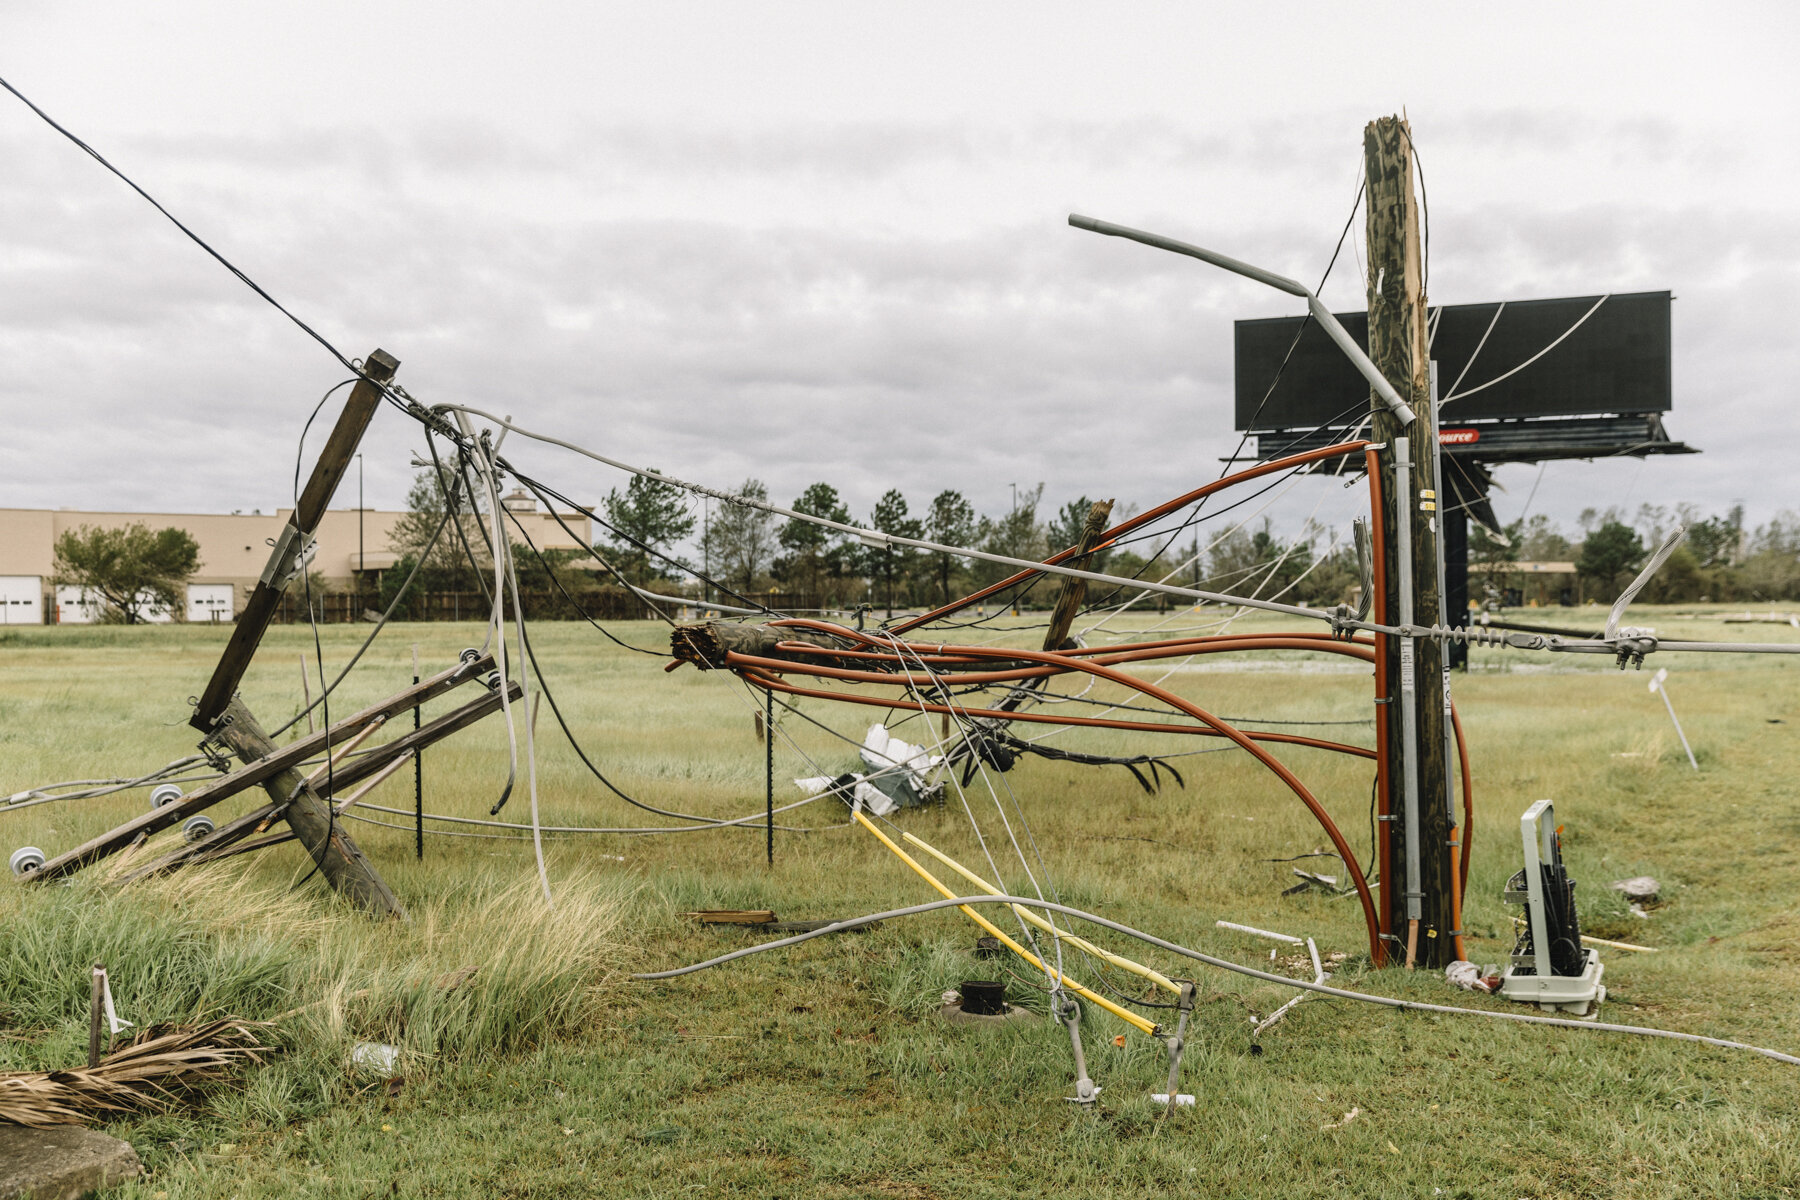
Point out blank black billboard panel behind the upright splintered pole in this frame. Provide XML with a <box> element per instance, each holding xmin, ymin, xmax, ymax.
<box><xmin>1237</xmin><ymin>291</ymin><xmax>1672</xmax><ymax>430</ymax></box>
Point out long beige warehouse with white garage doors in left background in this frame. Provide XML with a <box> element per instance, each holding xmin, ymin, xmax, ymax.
<box><xmin>0</xmin><ymin>491</ymin><xmax>592</xmax><ymax>624</ymax></box>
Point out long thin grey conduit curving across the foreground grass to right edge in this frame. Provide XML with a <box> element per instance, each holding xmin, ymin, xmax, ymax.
<box><xmin>632</xmin><ymin>896</ymin><xmax>1800</xmax><ymax>1067</ymax></box>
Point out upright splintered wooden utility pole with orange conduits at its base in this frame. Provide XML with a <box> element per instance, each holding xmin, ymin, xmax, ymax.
<box><xmin>1363</xmin><ymin>117</ymin><xmax>1458</xmax><ymax>968</ymax></box>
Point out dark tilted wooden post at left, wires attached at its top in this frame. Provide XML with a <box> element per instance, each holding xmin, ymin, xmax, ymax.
<box><xmin>187</xmin><ymin>341</ymin><xmax>400</xmax><ymax>734</ymax></box>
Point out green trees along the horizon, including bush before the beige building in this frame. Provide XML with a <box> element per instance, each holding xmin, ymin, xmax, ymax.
<box><xmin>45</xmin><ymin>471</ymin><xmax>1800</xmax><ymax>622</ymax></box>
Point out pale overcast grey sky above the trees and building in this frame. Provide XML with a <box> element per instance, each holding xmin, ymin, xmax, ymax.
<box><xmin>0</xmin><ymin>0</ymin><xmax>1800</xmax><ymax>554</ymax></box>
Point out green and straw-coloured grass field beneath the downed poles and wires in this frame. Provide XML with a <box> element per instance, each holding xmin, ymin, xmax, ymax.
<box><xmin>0</xmin><ymin>610</ymin><xmax>1800</xmax><ymax>1200</ymax></box>
